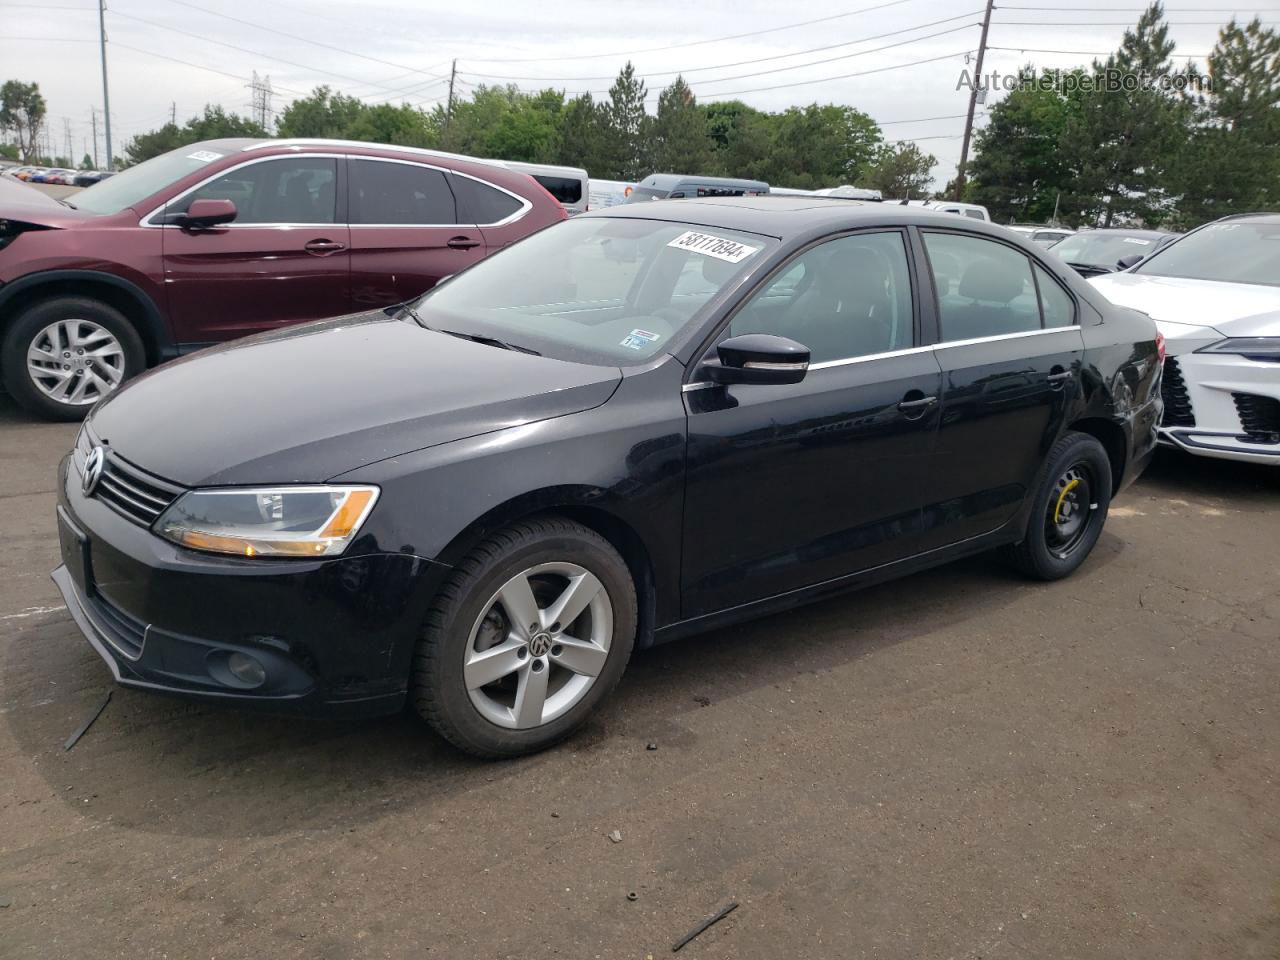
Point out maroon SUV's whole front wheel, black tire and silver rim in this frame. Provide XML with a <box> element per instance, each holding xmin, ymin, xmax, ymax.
<box><xmin>0</xmin><ymin>297</ymin><xmax>146</xmax><ymax>420</ymax></box>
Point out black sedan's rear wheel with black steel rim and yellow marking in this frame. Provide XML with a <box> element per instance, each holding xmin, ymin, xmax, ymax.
<box><xmin>1009</xmin><ymin>431</ymin><xmax>1111</xmax><ymax>580</ymax></box>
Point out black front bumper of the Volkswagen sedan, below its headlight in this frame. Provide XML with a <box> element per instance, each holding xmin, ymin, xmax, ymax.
<box><xmin>52</xmin><ymin>457</ymin><xmax>448</xmax><ymax>714</ymax></box>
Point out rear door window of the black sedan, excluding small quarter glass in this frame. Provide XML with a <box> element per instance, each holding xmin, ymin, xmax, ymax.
<box><xmin>924</xmin><ymin>232</ymin><xmax>1041</xmax><ymax>340</ymax></box>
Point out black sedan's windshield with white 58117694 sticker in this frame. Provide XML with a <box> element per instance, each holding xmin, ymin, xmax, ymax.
<box><xmin>415</xmin><ymin>218</ymin><xmax>777</xmax><ymax>366</ymax></box>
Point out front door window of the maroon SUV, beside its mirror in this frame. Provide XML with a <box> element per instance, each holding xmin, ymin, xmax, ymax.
<box><xmin>180</xmin><ymin>156</ymin><xmax>338</xmax><ymax>224</ymax></box>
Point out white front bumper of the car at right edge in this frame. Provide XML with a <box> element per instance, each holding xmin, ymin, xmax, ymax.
<box><xmin>1160</xmin><ymin>343</ymin><xmax>1280</xmax><ymax>466</ymax></box>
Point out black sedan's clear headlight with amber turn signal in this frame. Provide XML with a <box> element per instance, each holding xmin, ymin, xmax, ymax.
<box><xmin>155</xmin><ymin>486</ymin><xmax>378</xmax><ymax>557</ymax></box>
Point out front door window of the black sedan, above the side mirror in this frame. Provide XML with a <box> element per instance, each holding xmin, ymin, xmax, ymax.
<box><xmin>730</xmin><ymin>230</ymin><xmax>914</xmax><ymax>364</ymax></box>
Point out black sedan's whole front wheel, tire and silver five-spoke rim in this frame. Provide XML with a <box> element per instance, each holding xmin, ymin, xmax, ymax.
<box><xmin>411</xmin><ymin>517</ymin><xmax>636</xmax><ymax>759</ymax></box>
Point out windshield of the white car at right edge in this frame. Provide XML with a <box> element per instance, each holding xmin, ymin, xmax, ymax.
<box><xmin>1134</xmin><ymin>220</ymin><xmax>1280</xmax><ymax>287</ymax></box>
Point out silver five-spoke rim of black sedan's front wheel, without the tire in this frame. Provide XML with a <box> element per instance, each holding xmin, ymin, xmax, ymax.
<box><xmin>463</xmin><ymin>563</ymin><xmax>613</xmax><ymax>730</ymax></box>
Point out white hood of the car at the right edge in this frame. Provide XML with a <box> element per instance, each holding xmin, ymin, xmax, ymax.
<box><xmin>1089</xmin><ymin>273</ymin><xmax>1280</xmax><ymax>339</ymax></box>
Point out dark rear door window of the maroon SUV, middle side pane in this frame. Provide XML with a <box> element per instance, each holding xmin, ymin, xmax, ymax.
<box><xmin>347</xmin><ymin>159</ymin><xmax>458</xmax><ymax>225</ymax></box>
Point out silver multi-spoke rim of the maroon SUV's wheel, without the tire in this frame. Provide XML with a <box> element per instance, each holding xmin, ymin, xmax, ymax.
<box><xmin>27</xmin><ymin>320</ymin><xmax>124</xmax><ymax>407</ymax></box>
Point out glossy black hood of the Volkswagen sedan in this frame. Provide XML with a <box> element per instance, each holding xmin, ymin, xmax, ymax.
<box><xmin>90</xmin><ymin>312</ymin><xmax>622</xmax><ymax>486</ymax></box>
